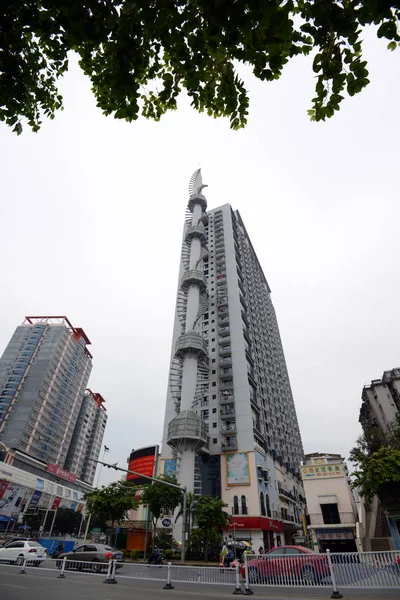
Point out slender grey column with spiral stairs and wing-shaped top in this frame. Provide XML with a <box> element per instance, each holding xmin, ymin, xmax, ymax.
<box><xmin>167</xmin><ymin>169</ymin><xmax>208</xmax><ymax>491</ymax></box>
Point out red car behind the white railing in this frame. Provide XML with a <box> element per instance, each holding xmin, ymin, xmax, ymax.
<box><xmin>241</xmin><ymin>546</ymin><xmax>329</xmax><ymax>585</ymax></box>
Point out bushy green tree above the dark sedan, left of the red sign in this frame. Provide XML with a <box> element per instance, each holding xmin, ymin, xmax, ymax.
<box><xmin>86</xmin><ymin>481</ymin><xmax>139</xmax><ymax>531</ymax></box>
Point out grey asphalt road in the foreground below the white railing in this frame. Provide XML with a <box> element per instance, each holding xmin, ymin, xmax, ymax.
<box><xmin>0</xmin><ymin>565</ymin><xmax>399</xmax><ymax>600</ymax></box>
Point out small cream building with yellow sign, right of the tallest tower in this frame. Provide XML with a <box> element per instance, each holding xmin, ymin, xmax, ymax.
<box><xmin>301</xmin><ymin>452</ymin><xmax>358</xmax><ymax>552</ymax></box>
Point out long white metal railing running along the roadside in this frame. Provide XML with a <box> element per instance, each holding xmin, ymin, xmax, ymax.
<box><xmin>0</xmin><ymin>549</ymin><xmax>400</xmax><ymax>598</ymax></box>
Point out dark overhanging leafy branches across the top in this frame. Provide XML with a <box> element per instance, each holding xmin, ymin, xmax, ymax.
<box><xmin>0</xmin><ymin>0</ymin><xmax>400</xmax><ymax>134</ymax></box>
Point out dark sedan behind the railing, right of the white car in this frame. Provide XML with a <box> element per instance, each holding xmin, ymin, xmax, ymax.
<box><xmin>57</xmin><ymin>544</ymin><xmax>124</xmax><ymax>573</ymax></box>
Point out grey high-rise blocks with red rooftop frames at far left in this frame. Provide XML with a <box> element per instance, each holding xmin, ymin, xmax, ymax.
<box><xmin>0</xmin><ymin>317</ymin><xmax>104</xmax><ymax>490</ymax></box>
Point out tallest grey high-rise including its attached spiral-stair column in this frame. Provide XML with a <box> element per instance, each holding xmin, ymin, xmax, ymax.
<box><xmin>161</xmin><ymin>170</ymin><xmax>304</xmax><ymax>548</ymax></box>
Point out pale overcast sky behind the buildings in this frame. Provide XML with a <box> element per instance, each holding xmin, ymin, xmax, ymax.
<box><xmin>0</xmin><ymin>27</ymin><xmax>400</xmax><ymax>483</ymax></box>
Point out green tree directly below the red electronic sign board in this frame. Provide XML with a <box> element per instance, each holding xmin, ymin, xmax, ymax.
<box><xmin>140</xmin><ymin>475</ymin><xmax>182</xmax><ymax>540</ymax></box>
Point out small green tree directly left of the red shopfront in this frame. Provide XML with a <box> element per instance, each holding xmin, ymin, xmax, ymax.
<box><xmin>194</xmin><ymin>496</ymin><xmax>230</xmax><ymax>560</ymax></box>
